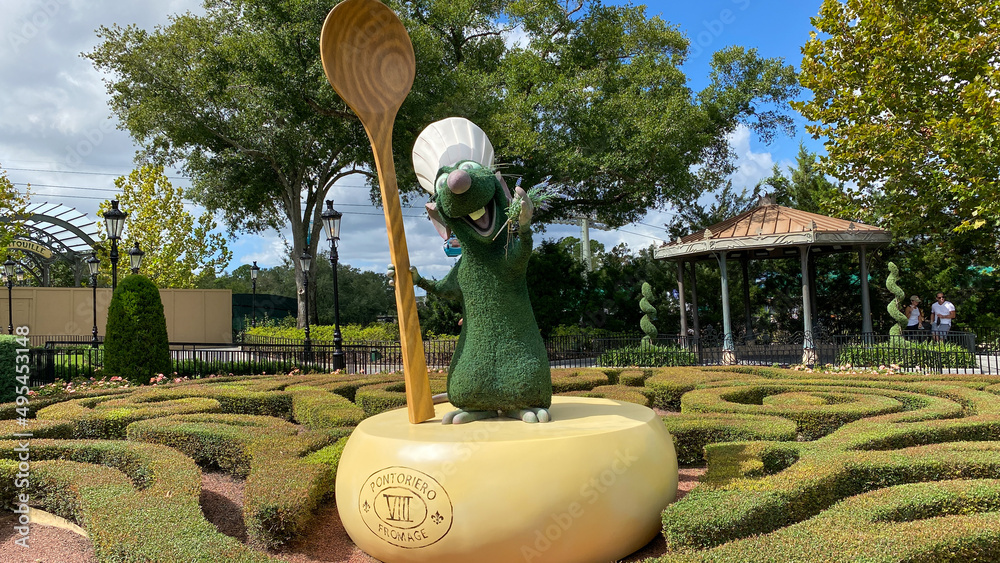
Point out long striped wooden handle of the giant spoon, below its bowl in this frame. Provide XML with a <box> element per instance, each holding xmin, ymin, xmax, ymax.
<box><xmin>365</xmin><ymin>124</ymin><xmax>434</xmax><ymax>424</ymax></box>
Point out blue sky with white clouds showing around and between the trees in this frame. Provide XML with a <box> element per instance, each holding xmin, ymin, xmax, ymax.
<box><xmin>0</xmin><ymin>0</ymin><xmax>822</xmax><ymax>277</ymax></box>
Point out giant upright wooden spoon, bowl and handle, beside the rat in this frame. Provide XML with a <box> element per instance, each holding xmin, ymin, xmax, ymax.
<box><xmin>320</xmin><ymin>0</ymin><xmax>434</xmax><ymax>424</ymax></box>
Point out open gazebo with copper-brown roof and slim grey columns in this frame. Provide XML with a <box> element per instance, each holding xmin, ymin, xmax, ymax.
<box><xmin>654</xmin><ymin>196</ymin><xmax>892</xmax><ymax>365</ymax></box>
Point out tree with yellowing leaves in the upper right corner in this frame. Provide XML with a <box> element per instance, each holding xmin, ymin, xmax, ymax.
<box><xmin>793</xmin><ymin>0</ymin><xmax>1000</xmax><ymax>238</ymax></box>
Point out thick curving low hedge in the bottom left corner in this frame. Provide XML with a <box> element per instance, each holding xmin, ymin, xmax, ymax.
<box><xmin>0</xmin><ymin>440</ymin><xmax>279</xmax><ymax>563</ymax></box>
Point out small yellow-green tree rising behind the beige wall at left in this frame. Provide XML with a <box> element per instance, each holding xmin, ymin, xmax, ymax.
<box><xmin>98</xmin><ymin>164</ymin><xmax>232</xmax><ymax>288</ymax></box>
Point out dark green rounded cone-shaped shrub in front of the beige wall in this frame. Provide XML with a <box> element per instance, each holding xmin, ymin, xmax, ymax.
<box><xmin>104</xmin><ymin>275</ymin><xmax>171</xmax><ymax>384</ymax></box>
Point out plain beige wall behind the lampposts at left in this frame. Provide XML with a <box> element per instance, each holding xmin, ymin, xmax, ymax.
<box><xmin>0</xmin><ymin>286</ymin><xmax>233</xmax><ymax>344</ymax></box>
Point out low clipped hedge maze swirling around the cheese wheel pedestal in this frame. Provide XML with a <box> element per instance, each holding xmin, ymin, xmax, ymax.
<box><xmin>0</xmin><ymin>367</ymin><xmax>1000</xmax><ymax>562</ymax></box>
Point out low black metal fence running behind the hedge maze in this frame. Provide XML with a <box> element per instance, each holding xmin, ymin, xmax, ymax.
<box><xmin>23</xmin><ymin>327</ymin><xmax>1000</xmax><ymax>385</ymax></box>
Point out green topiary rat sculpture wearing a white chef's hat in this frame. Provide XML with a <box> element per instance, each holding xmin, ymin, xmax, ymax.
<box><xmin>392</xmin><ymin>117</ymin><xmax>552</xmax><ymax>424</ymax></box>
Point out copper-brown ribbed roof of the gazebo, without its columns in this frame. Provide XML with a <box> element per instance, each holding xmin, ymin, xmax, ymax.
<box><xmin>654</xmin><ymin>199</ymin><xmax>892</xmax><ymax>260</ymax></box>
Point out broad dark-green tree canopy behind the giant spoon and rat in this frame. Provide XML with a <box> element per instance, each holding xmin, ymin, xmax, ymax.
<box><xmin>86</xmin><ymin>0</ymin><xmax>797</xmax><ymax>330</ymax></box>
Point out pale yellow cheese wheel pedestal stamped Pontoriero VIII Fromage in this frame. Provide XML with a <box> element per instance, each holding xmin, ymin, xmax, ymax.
<box><xmin>336</xmin><ymin>397</ymin><xmax>677</xmax><ymax>563</ymax></box>
